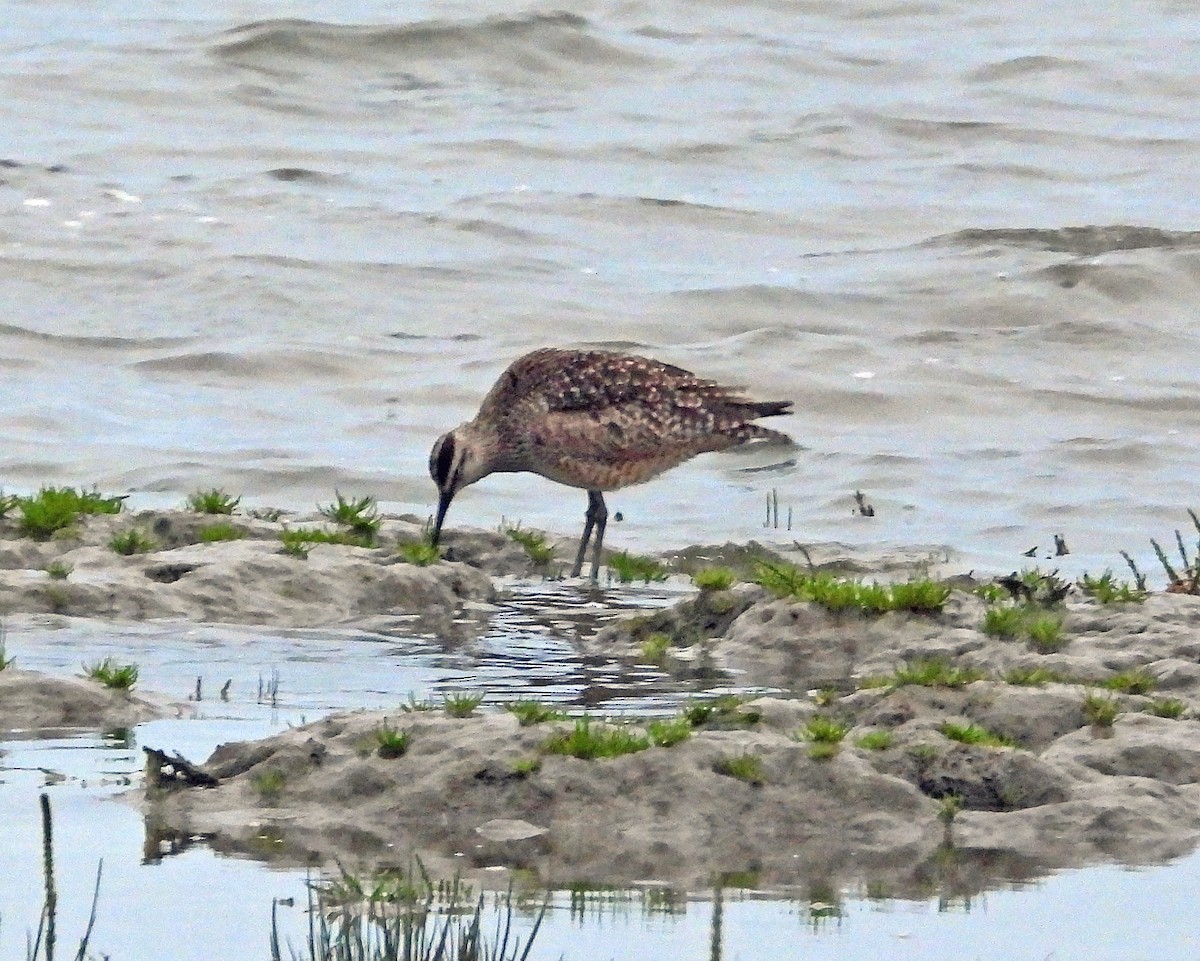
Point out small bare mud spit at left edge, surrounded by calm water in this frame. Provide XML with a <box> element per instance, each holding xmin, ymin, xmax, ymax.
<box><xmin>0</xmin><ymin>667</ymin><xmax>169</xmax><ymax>737</ymax></box>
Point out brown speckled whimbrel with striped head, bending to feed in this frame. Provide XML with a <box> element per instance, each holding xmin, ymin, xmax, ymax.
<box><xmin>430</xmin><ymin>348</ymin><xmax>792</xmax><ymax>581</ymax></box>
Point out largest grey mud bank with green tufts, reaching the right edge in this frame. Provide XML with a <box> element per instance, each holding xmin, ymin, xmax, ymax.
<box><xmin>136</xmin><ymin>566</ymin><xmax>1200</xmax><ymax>894</ymax></box>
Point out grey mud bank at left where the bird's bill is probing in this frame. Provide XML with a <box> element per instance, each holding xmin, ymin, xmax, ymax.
<box><xmin>0</xmin><ymin>511</ymin><xmax>516</xmax><ymax>629</ymax></box>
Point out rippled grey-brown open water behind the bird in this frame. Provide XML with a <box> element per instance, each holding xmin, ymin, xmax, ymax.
<box><xmin>0</xmin><ymin>0</ymin><xmax>1200</xmax><ymax>571</ymax></box>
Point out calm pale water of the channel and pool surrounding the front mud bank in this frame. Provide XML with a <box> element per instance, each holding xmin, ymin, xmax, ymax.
<box><xmin>7</xmin><ymin>584</ymin><xmax>1200</xmax><ymax>961</ymax></box>
